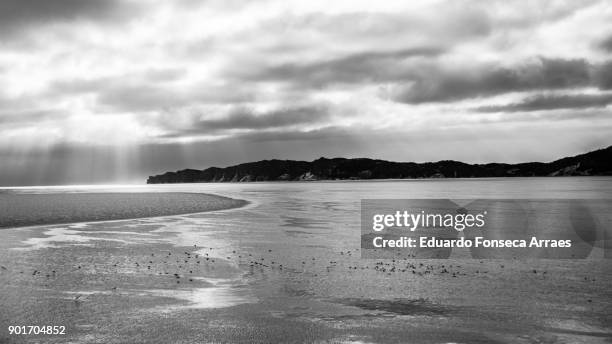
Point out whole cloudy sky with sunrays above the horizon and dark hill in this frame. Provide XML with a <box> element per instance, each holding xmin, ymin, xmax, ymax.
<box><xmin>0</xmin><ymin>0</ymin><xmax>612</xmax><ymax>185</ymax></box>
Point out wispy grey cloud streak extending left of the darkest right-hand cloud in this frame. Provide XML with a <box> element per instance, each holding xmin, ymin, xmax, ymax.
<box><xmin>239</xmin><ymin>47</ymin><xmax>444</xmax><ymax>87</ymax></box>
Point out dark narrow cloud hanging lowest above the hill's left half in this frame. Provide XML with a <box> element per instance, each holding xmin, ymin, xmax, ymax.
<box><xmin>164</xmin><ymin>106</ymin><xmax>330</xmax><ymax>137</ymax></box>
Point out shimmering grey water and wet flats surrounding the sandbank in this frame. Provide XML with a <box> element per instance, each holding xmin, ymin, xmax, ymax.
<box><xmin>0</xmin><ymin>177</ymin><xmax>612</xmax><ymax>343</ymax></box>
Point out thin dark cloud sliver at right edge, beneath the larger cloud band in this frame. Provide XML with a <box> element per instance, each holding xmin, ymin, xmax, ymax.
<box><xmin>477</xmin><ymin>94</ymin><xmax>612</xmax><ymax>112</ymax></box>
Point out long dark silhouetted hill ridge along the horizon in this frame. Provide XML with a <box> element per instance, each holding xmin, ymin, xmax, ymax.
<box><xmin>147</xmin><ymin>146</ymin><xmax>612</xmax><ymax>184</ymax></box>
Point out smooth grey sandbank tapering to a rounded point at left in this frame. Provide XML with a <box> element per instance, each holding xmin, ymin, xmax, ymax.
<box><xmin>0</xmin><ymin>192</ymin><xmax>249</xmax><ymax>229</ymax></box>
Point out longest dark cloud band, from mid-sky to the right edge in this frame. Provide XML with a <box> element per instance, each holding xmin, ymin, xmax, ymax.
<box><xmin>232</xmin><ymin>47</ymin><xmax>612</xmax><ymax>104</ymax></box>
